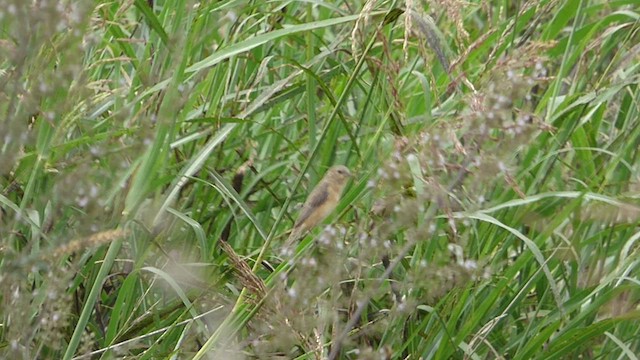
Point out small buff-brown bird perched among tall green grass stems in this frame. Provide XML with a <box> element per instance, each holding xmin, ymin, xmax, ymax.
<box><xmin>284</xmin><ymin>165</ymin><xmax>351</xmax><ymax>249</ymax></box>
